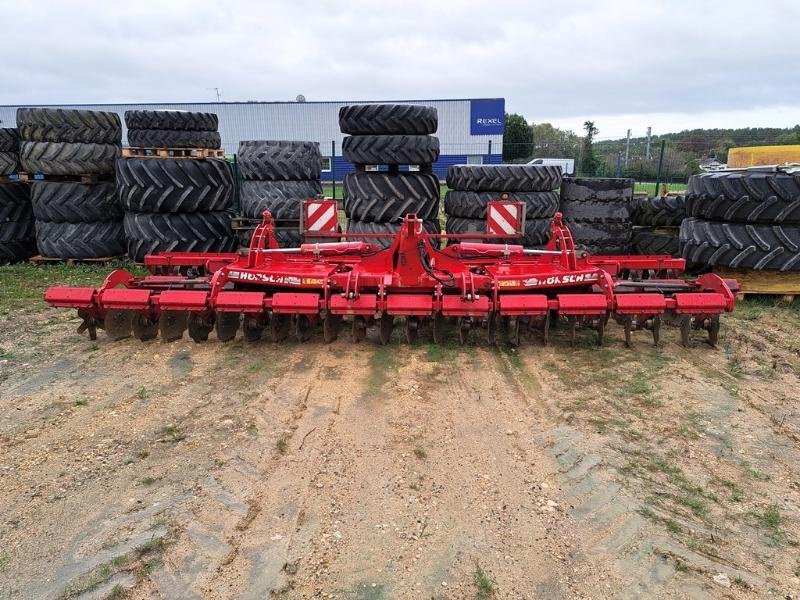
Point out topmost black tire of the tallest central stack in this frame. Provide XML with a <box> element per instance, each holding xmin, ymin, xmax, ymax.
<box><xmin>339</xmin><ymin>104</ymin><xmax>439</xmax><ymax>135</ymax></box>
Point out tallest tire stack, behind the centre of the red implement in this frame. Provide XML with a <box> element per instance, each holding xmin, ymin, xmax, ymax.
<box><xmin>339</xmin><ymin>104</ymin><xmax>441</xmax><ymax>248</ymax></box>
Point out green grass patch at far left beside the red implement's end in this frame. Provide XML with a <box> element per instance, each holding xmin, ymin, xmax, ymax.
<box><xmin>0</xmin><ymin>260</ymin><xmax>144</xmax><ymax>314</ymax></box>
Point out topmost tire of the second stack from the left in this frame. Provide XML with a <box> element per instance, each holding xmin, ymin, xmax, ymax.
<box><xmin>17</xmin><ymin>108</ymin><xmax>122</xmax><ymax>144</ymax></box>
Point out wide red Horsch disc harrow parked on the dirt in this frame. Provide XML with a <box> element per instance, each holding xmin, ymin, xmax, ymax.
<box><xmin>40</xmin><ymin>203</ymin><xmax>736</xmax><ymax>345</ymax></box>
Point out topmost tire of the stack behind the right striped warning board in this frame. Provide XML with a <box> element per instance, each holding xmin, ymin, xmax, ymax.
<box><xmin>447</xmin><ymin>165</ymin><xmax>561</xmax><ymax>192</ymax></box>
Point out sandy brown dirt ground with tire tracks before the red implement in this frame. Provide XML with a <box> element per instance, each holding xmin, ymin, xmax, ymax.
<box><xmin>0</xmin><ymin>270</ymin><xmax>800</xmax><ymax>600</ymax></box>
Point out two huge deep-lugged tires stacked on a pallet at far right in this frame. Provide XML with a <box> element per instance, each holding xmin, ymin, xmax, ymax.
<box><xmin>680</xmin><ymin>171</ymin><xmax>800</xmax><ymax>271</ymax></box>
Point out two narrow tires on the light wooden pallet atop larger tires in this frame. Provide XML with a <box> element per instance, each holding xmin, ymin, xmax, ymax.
<box><xmin>125</xmin><ymin>110</ymin><xmax>221</xmax><ymax>148</ymax></box>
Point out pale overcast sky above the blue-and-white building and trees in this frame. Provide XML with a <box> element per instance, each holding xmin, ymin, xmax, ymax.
<box><xmin>0</xmin><ymin>0</ymin><xmax>800</xmax><ymax>139</ymax></box>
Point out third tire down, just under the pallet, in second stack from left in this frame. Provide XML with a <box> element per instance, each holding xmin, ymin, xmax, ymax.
<box><xmin>31</xmin><ymin>181</ymin><xmax>124</xmax><ymax>223</ymax></box>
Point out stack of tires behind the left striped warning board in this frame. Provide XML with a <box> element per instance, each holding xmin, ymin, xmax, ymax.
<box><xmin>237</xmin><ymin>140</ymin><xmax>322</xmax><ymax>248</ymax></box>
